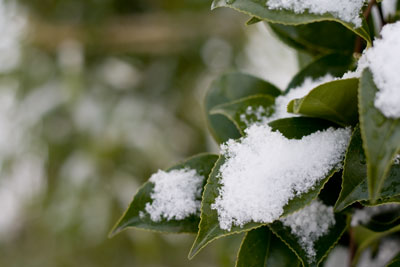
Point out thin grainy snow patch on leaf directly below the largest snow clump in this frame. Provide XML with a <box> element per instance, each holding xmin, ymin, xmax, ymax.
<box><xmin>281</xmin><ymin>200</ymin><xmax>336</xmax><ymax>262</ymax></box>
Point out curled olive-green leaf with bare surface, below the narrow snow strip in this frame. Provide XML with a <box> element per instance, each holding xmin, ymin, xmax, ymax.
<box><xmin>288</xmin><ymin>78</ymin><xmax>358</xmax><ymax>126</ymax></box>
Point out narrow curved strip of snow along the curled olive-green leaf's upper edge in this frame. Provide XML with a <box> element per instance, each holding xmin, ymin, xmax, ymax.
<box><xmin>269</xmin><ymin>74</ymin><xmax>334</xmax><ymax>121</ymax></box>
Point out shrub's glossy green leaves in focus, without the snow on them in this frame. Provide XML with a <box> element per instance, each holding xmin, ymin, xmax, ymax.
<box><xmin>114</xmin><ymin>0</ymin><xmax>400</xmax><ymax>266</ymax></box>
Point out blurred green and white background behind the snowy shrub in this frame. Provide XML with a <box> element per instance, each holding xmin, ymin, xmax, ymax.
<box><xmin>0</xmin><ymin>0</ymin><xmax>298</xmax><ymax>267</ymax></box>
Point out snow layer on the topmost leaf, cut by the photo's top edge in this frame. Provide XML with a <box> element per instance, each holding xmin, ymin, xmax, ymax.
<box><xmin>267</xmin><ymin>0</ymin><xmax>365</xmax><ymax>28</ymax></box>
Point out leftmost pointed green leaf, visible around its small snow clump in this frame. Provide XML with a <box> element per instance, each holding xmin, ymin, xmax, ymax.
<box><xmin>110</xmin><ymin>154</ymin><xmax>218</xmax><ymax>236</ymax></box>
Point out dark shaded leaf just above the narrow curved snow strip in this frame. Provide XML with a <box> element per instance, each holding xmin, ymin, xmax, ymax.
<box><xmin>285</xmin><ymin>54</ymin><xmax>353</xmax><ymax>93</ymax></box>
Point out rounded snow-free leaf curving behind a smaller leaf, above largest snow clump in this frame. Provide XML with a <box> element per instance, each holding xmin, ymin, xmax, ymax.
<box><xmin>205</xmin><ymin>73</ymin><xmax>281</xmax><ymax>143</ymax></box>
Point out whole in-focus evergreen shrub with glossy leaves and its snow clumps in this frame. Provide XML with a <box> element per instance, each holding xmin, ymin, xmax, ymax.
<box><xmin>111</xmin><ymin>0</ymin><xmax>400</xmax><ymax>267</ymax></box>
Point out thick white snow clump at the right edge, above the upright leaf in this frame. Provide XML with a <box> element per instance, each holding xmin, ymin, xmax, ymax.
<box><xmin>343</xmin><ymin>22</ymin><xmax>400</xmax><ymax>119</ymax></box>
